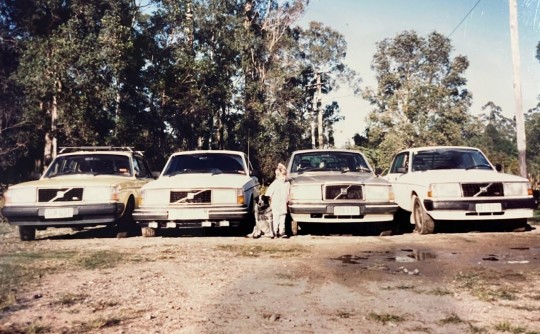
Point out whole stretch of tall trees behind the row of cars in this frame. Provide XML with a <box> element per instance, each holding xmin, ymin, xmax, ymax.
<box><xmin>0</xmin><ymin>0</ymin><xmax>540</xmax><ymax>186</ymax></box>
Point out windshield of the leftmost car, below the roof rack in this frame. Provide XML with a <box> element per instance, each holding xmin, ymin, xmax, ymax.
<box><xmin>45</xmin><ymin>154</ymin><xmax>133</xmax><ymax>177</ymax></box>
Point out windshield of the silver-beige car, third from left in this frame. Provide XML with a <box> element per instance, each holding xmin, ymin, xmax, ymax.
<box><xmin>291</xmin><ymin>152</ymin><xmax>371</xmax><ymax>173</ymax></box>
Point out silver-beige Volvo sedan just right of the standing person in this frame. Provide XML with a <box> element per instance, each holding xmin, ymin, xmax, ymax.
<box><xmin>287</xmin><ymin>149</ymin><xmax>398</xmax><ymax>235</ymax></box>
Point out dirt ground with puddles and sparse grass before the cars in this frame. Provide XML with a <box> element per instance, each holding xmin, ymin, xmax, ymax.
<box><xmin>0</xmin><ymin>224</ymin><xmax>540</xmax><ymax>334</ymax></box>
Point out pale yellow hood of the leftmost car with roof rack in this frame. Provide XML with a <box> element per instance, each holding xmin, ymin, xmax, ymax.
<box><xmin>10</xmin><ymin>174</ymin><xmax>134</xmax><ymax>189</ymax></box>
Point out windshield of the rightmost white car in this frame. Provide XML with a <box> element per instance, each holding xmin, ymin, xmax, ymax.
<box><xmin>412</xmin><ymin>149</ymin><xmax>493</xmax><ymax>171</ymax></box>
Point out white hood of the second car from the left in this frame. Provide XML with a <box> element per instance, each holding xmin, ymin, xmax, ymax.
<box><xmin>143</xmin><ymin>173</ymin><xmax>255</xmax><ymax>189</ymax></box>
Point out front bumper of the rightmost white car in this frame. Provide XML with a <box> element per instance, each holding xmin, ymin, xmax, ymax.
<box><xmin>424</xmin><ymin>198</ymin><xmax>537</xmax><ymax>220</ymax></box>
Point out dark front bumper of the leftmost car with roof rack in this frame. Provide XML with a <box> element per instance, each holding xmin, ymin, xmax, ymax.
<box><xmin>2</xmin><ymin>203</ymin><xmax>124</xmax><ymax>227</ymax></box>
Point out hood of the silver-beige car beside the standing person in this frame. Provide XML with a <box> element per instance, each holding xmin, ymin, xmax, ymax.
<box><xmin>291</xmin><ymin>172</ymin><xmax>388</xmax><ymax>184</ymax></box>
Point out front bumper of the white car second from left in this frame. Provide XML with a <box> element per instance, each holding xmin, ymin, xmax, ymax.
<box><xmin>133</xmin><ymin>206</ymin><xmax>249</xmax><ymax>228</ymax></box>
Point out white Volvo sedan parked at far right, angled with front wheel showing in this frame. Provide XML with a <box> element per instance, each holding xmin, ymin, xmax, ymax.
<box><xmin>384</xmin><ymin>146</ymin><xmax>536</xmax><ymax>234</ymax></box>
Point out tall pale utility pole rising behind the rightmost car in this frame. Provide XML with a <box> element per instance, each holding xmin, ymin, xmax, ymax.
<box><xmin>508</xmin><ymin>0</ymin><xmax>527</xmax><ymax>177</ymax></box>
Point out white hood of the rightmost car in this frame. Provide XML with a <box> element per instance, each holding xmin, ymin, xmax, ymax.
<box><xmin>402</xmin><ymin>169</ymin><xmax>528</xmax><ymax>184</ymax></box>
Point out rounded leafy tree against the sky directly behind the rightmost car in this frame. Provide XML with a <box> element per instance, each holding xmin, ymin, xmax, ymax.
<box><xmin>364</xmin><ymin>31</ymin><xmax>472</xmax><ymax>167</ymax></box>
